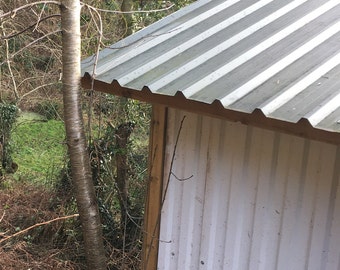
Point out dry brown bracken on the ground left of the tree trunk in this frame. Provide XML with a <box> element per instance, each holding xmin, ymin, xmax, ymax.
<box><xmin>0</xmin><ymin>181</ymin><xmax>84</xmax><ymax>270</ymax></box>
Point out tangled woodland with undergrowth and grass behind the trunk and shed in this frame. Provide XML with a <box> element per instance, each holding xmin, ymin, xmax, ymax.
<box><xmin>0</xmin><ymin>0</ymin><xmax>192</xmax><ymax>269</ymax></box>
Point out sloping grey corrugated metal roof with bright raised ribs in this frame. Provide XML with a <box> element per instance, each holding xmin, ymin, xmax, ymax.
<box><xmin>82</xmin><ymin>0</ymin><xmax>340</xmax><ymax>133</ymax></box>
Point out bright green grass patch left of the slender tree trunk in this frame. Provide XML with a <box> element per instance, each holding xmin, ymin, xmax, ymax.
<box><xmin>11</xmin><ymin>113</ymin><xmax>66</xmax><ymax>184</ymax></box>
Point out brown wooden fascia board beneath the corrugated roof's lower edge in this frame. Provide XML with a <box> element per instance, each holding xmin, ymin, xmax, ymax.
<box><xmin>81</xmin><ymin>74</ymin><xmax>340</xmax><ymax>145</ymax></box>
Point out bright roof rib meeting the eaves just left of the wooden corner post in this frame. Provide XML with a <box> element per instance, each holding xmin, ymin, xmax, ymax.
<box><xmin>148</xmin><ymin>0</ymin><xmax>307</xmax><ymax>91</ymax></box>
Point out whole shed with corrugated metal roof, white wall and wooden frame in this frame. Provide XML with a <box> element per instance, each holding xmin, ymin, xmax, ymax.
<box><xmin>82</xmin><ymin>0</ymin><xmax>340</xmax><ymax>270</ymax></box>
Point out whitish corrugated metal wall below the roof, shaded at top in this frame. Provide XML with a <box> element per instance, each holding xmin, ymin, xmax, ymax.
<box><xmin>158</xmin><ymin>109</ymin><xmax>340</xmax><ymax>270</ymax></box>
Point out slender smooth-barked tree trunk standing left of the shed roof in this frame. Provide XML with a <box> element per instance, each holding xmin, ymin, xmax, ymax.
<box><xmin>61</xmin><ymin>0</ymin><xmax>106</xmax><ymax>270</ymax></box>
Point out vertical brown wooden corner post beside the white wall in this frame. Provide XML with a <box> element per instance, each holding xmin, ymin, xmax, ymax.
<box><xmin>142</xmin><ymin>104</ymin><xmax>167</xmax><ymax>270</ymax></box>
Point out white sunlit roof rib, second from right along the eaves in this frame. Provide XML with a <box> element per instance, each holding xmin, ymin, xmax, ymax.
<box><xmin>260</xmin><ymin>52</ymin><xmax>340</xmax><ymax>115</ymax></box>
